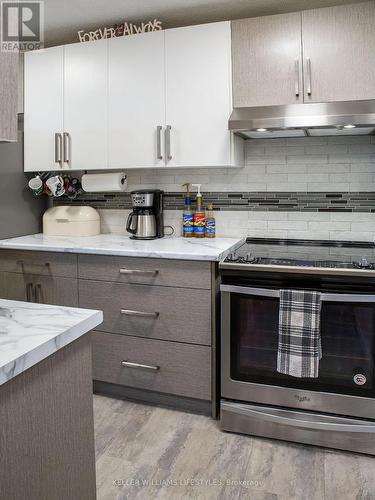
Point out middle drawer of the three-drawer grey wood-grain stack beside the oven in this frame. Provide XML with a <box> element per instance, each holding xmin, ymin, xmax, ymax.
<box><xmin>79</xmin><ymin>280</ymin><xmax>211</xmax><ymax>345</ymax></box>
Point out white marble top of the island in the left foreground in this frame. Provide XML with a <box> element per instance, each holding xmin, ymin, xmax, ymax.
<box><xmin>0</xmin><ymin>299</ymin><xmax>103</xmax><ymax>385</ymax></box>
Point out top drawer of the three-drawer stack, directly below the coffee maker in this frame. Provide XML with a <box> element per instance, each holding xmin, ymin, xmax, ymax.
<box><xmin>78</xmin><ymin>255</ymin><xmax>211</xmax><ymax>290</ymax></box>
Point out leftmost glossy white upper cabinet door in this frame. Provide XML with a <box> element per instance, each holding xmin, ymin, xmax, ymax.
<box><xmin>24</xmin><ymin>47</ymin><xmax>64</xmax><ymax>172</ymax></box>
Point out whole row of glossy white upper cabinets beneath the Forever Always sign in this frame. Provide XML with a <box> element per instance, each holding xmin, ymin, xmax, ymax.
<box><xmin>25</xmin><ymin>21</ymin><xmax>243</xmax><ymax>171</ymax></box>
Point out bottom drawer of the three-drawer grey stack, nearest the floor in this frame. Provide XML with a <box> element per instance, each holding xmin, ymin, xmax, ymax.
<box><xmin>92</xmin><ymin>332</ymin><xmax>211</xmax><ymax>400</ymax></box>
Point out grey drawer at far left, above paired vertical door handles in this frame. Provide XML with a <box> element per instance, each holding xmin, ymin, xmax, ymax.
<box><xmin>0</xmin><ymin>250</ymin><xmax>77</xmax><ymax>278</ymax></box>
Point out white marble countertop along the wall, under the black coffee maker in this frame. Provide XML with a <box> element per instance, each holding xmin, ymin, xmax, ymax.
<box><xmin>0</xmin><ymin>234</ymin><xmax>243</xmax><ymax>261</ymax></box>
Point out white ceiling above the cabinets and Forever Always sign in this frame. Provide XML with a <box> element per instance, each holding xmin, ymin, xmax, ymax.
<box><xmin>44</xmin><ymin>0</ymin><xmax>363</xmax><ymax>46</ymax></box>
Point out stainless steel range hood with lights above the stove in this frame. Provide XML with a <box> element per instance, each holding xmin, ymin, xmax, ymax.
<box><xmin>229</xmin><ymin>100</ymin><xmax>375</xmax><ymax>139</ymax></box>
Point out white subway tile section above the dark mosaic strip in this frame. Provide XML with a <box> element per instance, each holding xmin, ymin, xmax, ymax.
<box><xmin>113</xmin><ymin>136</ymin><xmax>375</xmax><ymax>192</ymax></box>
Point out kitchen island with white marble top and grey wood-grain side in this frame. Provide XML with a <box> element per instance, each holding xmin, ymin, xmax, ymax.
<box><xmin>0</xmin><ymin>300</ymin><xmax>103</xmax><ymax>500</ymax></box>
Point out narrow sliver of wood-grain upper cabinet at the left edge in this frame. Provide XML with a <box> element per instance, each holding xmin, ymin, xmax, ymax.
<box><xmin>0</xmin><ymin>52</ymin><xmax>19</xmax><ymax>142</ymax></box>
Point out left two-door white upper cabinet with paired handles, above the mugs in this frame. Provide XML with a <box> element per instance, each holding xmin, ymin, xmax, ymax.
<box><xmin>24</xmin><ymin>41</ymin><xmax>108</xmax><ymax>171</ymax></box>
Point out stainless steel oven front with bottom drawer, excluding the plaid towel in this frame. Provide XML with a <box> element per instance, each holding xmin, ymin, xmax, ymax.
<box><xmin>221</xmin><ymin>280</ymin><xmax>375</xmax><ymax>454</ymax></box>
